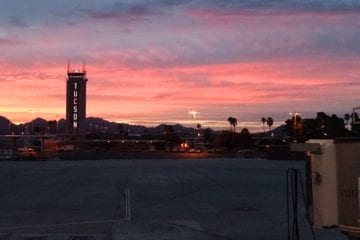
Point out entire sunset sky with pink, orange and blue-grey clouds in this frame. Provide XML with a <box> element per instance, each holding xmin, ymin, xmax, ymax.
<box><xmin>0</xmin><ymin>0</ymin><xmax>360</xmax><ymax>131</ymax></box>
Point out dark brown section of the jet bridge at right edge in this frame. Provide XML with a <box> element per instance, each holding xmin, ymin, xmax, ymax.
<box><xmin>335</xmin><ymin>138</ymin><xmax>360</xmax><ymax>237</ymax></box>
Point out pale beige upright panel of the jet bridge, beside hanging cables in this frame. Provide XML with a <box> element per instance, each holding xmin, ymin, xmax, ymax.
<box><xmin>308</xmin><ymin>139</ymin><xmax>338</xmax><ymax>227</ymax></box>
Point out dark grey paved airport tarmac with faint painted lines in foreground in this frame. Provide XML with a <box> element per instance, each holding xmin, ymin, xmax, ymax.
<box><xmin>0</xmin><ymin>159</ymin><xmax>346</xmax><ymax>240</ymax></box>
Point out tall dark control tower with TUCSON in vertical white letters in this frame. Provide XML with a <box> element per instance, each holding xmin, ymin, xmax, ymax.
<box><xmin>66</xmin><ymin>62</ymin><xmax>87</xmax><ymax>136</ymax></box>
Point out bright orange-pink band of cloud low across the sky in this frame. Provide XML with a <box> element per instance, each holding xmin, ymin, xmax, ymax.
<box><xmin>0</xmin><ymin>55</ymin><xmax>360</xmax><ymax>124</ymax></box>
